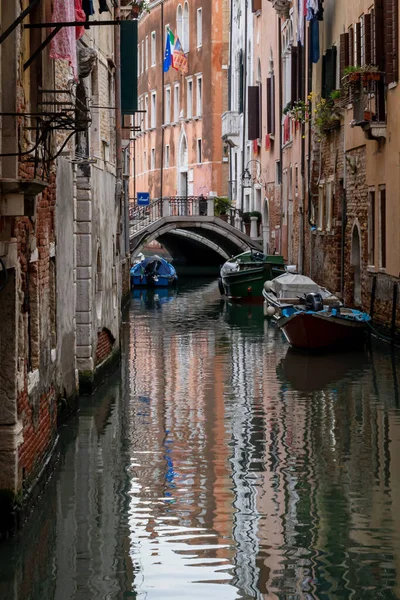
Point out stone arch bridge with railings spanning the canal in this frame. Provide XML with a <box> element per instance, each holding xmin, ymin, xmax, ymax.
<box><xmin>129</xmin><ymin>197</ymin><xmax>262</xmax><ymax>266</ymax></box>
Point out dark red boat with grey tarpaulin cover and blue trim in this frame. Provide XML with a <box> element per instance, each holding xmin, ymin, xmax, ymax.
<box><xmin>263</xmin><ymin>273</ymin><xmax>371</xmax><ymax>351</ymax></box>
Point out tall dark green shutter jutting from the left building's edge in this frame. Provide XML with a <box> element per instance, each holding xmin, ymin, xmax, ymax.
<box><xmin>121</xmin><ymin>20</ymin><xmax>138</xmax><ymax>115</ymax></box>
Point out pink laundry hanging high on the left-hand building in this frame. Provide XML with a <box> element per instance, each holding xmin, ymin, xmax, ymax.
<box><xmin>50</xmin><ymin>0</ymin><xmax>78</xmax><ymax>80</ymax></box>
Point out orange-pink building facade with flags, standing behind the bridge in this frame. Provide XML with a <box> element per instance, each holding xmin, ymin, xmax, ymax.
<box><xmin>131</xmin><ymin>0</ymin><xmax>229</xmax><ymax>198</ymax></box>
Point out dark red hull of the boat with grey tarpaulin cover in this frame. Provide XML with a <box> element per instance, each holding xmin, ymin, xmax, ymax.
<box><xmin>278</xmin><ymin>312</ymin><xmax>367</xmax><ymax>351</ymax></box>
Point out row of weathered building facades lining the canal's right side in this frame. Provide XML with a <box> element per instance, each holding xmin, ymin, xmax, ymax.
<box><xmin>223</xmin><ymin>0</ymin><xmax>400</xmax><ymax>327</ymax></box>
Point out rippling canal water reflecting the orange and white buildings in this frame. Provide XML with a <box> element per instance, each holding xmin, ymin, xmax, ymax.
<box><xmin>0</xmin><ymin>282</ymin><xmax>400</xmax><ymax>600</ymax></box>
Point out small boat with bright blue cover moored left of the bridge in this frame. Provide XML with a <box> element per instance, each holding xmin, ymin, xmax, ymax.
<box><xmin>130</xmin><ymin>255</ymin><xmax>178</xmax><ymax>288</ymax></box>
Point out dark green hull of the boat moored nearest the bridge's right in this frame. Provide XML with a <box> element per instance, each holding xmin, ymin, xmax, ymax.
<box><xmin>222</xmin><ymin>264</ymin><xmax>283</xmax><ymax>303</ymax></box>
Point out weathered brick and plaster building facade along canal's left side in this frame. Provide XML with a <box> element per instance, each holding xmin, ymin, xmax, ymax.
<box><xmin>0</xmin><ymin>0</ymin><xmax>129</xmax><ymax>535</ymax></box>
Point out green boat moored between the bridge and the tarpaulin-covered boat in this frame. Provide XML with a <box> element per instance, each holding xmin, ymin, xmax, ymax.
<box><xmin>218</xmin><ymin>250</ymin><xmax>285</xmax><ymax>302</ymax></box>
